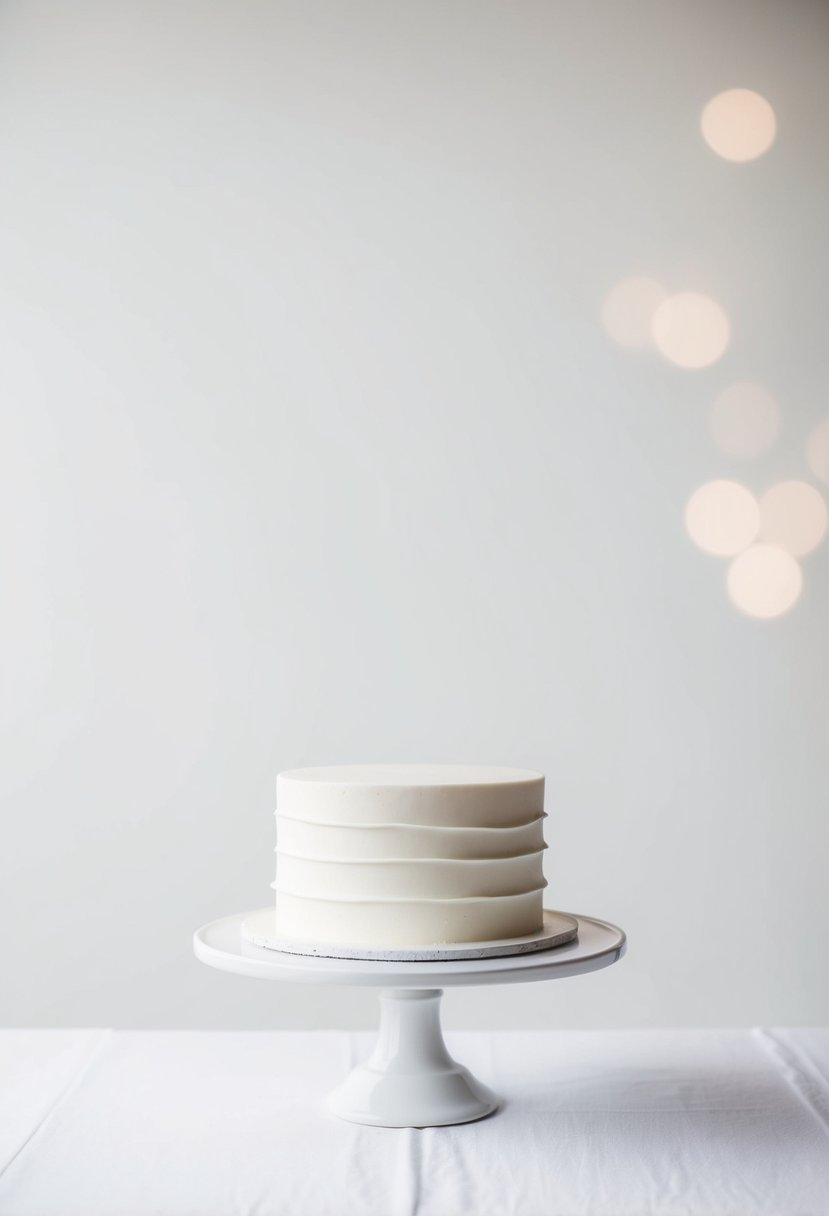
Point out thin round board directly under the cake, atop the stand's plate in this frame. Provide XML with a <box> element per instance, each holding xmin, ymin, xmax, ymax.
<box><xmin>242</xmin><ymin>907</ymin><xmax>579</xmax><ymax>963</ymax></box>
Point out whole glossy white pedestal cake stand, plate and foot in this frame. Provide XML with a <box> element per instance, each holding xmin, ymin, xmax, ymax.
<box><xmin>193</xmin><ymin>912</ymin><xmax>626</xmax><ymax>1127</ymax></box>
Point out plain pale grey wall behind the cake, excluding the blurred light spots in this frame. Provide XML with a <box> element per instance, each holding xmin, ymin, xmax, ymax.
<box><xmin>0</xmin><ymin>0</ymin><xmax>829</xmax><ymax>1028</ymax></box>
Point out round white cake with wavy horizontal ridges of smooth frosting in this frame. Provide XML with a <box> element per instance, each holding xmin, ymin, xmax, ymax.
<box><xmin>273</xmin><ymin>765</ymin><xmax>546</xmax><ymax>950</ymax></box>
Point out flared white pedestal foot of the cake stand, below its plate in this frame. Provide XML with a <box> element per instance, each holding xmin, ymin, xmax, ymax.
<box><xmin>328</xmin><ymin>989</ymin><xmax>498</xmax><ymax>1127</ymax></box>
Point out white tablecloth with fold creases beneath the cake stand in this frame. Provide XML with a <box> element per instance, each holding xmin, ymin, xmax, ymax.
<box><xmin>0</xmin><ymin>1029</ymin><xmax>829</xmax><ymax>1216</ymax></box>
